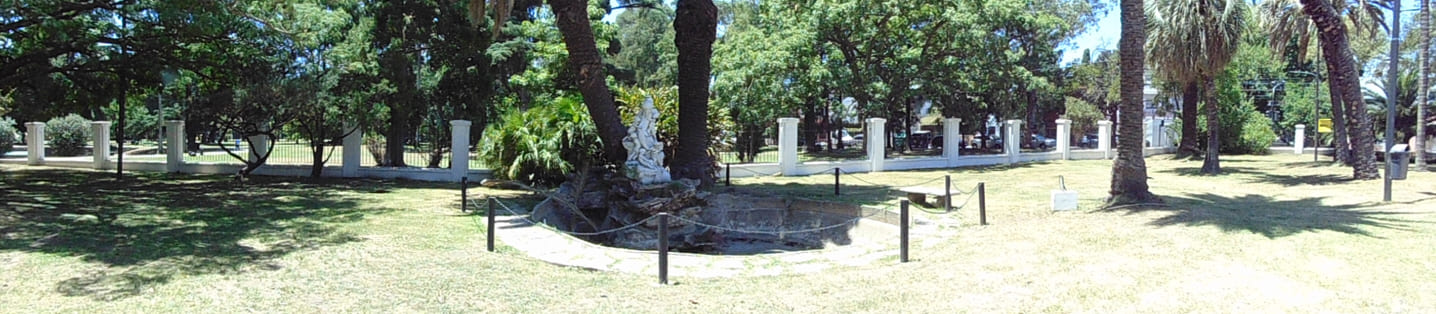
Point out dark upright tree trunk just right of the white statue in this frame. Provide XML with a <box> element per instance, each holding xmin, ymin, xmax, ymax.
<box><xmin>671</xmin><ymin>0</ymin><xmax>718</xmax><ymax>185</ymax></box>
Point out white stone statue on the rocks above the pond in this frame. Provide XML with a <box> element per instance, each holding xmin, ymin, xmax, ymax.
<box><xmin>623</xmin><ymin>97</ymin><xmax>672</xmax><ymax>184</ymax></box>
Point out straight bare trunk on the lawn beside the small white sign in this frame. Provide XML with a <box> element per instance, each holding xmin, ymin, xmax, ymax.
<box><xmin>1107</xmin><ymin>0</ymin><xmax>1162</xmax><ymax>208</ymax></box>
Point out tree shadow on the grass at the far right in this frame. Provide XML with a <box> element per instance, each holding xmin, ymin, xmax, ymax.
<box><xmin>1116</xmin><ymin>194</ymin><xmax>1426</xmax><ymax>239</ymax></box>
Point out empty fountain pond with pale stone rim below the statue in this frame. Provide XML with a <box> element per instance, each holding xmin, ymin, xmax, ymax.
<box><xmin>514</xmin><ymin>191</ymin><xmax>916</xmax><ymax>277</ymax></box>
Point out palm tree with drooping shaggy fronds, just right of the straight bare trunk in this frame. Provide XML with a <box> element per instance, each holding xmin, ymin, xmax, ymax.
<box><xmin>1146</xmin><ymin>0</ymin><xmax>1246</xmax><ymax>173</ymax></box>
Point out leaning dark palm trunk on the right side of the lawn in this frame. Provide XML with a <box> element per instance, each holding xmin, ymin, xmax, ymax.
<box><xmin>1301</xmin><ymin>0</ymin><xmax>1380</xmax><ymax>179</ymax></box>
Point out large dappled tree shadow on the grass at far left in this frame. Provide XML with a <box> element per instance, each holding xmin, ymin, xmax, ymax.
<box><xmin>0</xmin><ymin>169</ymin><xmax>387</xmax><ymax>300</ymax></box>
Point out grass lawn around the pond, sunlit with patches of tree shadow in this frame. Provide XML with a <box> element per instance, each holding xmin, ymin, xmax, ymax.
<box><xmin>0</xmin><ymin>155</ymin><xmax>1436</xmax><ymax>313</ymax></box>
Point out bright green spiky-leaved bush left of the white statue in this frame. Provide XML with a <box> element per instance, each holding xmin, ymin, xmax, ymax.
<box><xmin>480</xmin><ymin>96</ymin><xmax>603</xmax><ymax>185</ymax></box>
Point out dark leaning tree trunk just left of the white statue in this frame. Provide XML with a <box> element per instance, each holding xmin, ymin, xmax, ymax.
<box><xmin>549</xmin><ymin>0</ymin><xmax>628</xmax><ymax>165</ymax></box>
